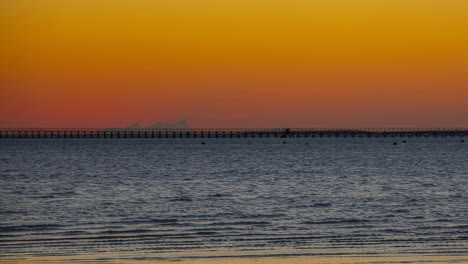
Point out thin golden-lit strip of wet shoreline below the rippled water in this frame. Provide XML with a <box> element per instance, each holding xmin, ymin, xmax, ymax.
<box><xmin>0</xmin><ymin>255</ymin><xmax>468</xmax><ymax>264</ymax></box>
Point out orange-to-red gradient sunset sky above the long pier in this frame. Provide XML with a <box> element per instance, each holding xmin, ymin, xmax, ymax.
<box><xmin>0</xmin><ymin>0</ymin><xmax>468</xmax><ymax>127</ymax></box>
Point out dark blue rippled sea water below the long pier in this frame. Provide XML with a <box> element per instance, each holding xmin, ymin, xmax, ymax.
<box><xmin>0</xmin><ymin>139</ymin><xmax>468</xmax><ymax>261</ymax></box>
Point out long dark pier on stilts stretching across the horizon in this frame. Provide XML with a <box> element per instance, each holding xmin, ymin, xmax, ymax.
<box><xmin>0</xmin><ymin>128</ymin><xmax>468</xmax><ymax>139</ymax></box>
